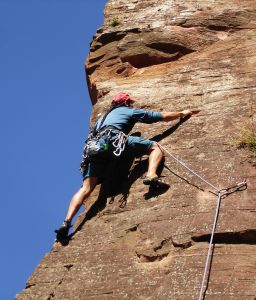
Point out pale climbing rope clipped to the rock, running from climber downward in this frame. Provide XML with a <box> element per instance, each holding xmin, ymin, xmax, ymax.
<box><xmin>157</xmin><ymin>143</ymin><xmax>247</xmax><ymax>300</ymax></box>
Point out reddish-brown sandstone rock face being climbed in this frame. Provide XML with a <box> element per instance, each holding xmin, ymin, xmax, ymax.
<box><xmin>17</xmin><ymin>0</ymin><xmax>256</xmax><ymax>300</ymax></box>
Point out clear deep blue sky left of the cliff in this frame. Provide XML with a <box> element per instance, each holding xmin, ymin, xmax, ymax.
<box><xmin>0</xmin><ymin>0</ymin><xmax>106</xmax><ymax>300</ymax></box>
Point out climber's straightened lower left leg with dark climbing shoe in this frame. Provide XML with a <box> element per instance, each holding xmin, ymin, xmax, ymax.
<box><xmin>55</xmin><ymin>177</ymin><xmax>98</xmax><ymax>240</ymax></box>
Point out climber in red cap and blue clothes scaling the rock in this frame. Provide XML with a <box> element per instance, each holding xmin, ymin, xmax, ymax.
<box><xmin>56</xmin><ymin>92</ymin><xmax>197</xmax><ymax>240</ymax></box>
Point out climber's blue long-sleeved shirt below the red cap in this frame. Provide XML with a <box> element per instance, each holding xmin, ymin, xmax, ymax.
<box><xmin>95</xmin><ymin>106</ymin><xmax>163</xmax><ymax>134</ymax></box>
